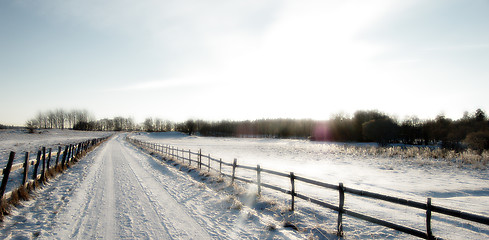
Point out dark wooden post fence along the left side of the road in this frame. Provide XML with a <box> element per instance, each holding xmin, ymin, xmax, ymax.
<box><xmin>0</xmin><ymin>137</ymin><xmax>109</xmax><ymax>202</ymax></box>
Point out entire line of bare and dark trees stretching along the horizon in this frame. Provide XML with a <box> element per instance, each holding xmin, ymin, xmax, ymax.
<box><xmin>23</xmin><ymin>109</ymin><xmax>489</xmax><ymax>151</ymax></box>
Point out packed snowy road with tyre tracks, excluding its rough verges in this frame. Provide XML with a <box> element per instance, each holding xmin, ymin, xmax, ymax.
<box><xmin>48</xmin><ymin>136</ymin><xmax>211</xmax><ymax>239</ymax></box>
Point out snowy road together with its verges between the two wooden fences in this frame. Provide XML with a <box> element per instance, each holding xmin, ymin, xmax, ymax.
<box><xmin>0</xmin><ymin>134</ymin><xmax>304</xmax><ymax>239</ymax></box>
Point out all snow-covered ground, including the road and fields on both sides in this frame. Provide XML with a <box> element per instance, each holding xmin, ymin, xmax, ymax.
<box><xmin>0</xmin><ymin>130</ymin><xmax>489</xmax><ymax>239</ymax></box>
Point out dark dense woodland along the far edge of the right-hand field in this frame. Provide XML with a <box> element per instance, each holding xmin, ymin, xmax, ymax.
<box><xmin>165</xmin><ymin>109</ymin><xmax>489</xmax><ymax>150</ymax></box>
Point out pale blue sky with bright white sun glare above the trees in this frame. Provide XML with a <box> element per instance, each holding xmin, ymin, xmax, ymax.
<box><xmin>0</xmin><ymin>0</ymin><xmax>489</xmax><ymax>125</ymax></box>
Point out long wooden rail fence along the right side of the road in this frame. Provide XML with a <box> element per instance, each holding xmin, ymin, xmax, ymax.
<box><xmin>127</xmin><ymin>138</ymin><xmax>489</xmax><ymax>239</ymax></box>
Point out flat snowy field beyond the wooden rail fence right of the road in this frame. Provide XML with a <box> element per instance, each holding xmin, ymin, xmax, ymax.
<box><xmin>131</xmin><ymin>133</ymin><xmax>489</xmax><ymax>239</ymax></box>
